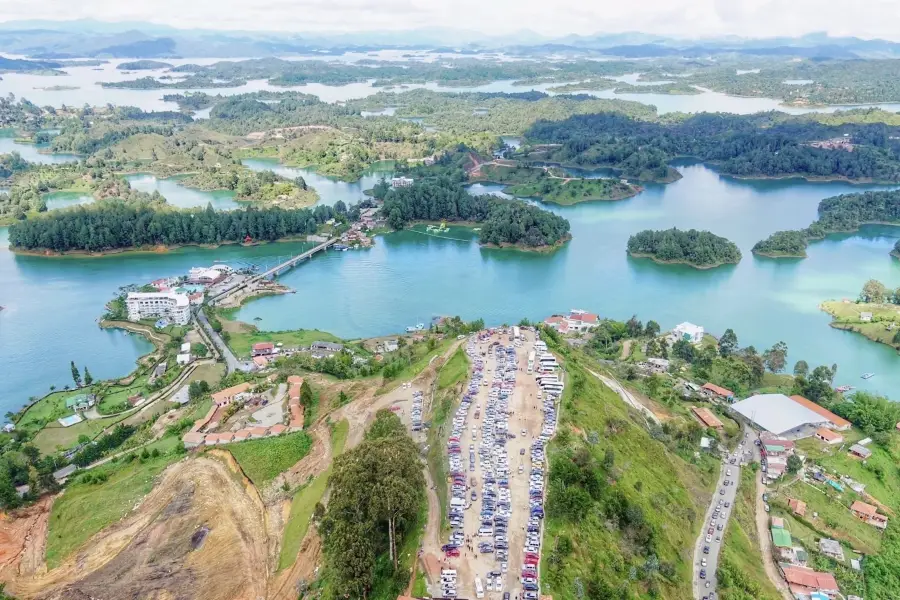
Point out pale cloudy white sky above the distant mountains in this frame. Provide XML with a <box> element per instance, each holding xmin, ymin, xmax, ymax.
<box><xmin>0</xmin><ymin>0</ymin><xmax>900</xmax><ymax>41</ymax></box>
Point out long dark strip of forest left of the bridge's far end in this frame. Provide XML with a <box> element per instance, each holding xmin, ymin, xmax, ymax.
<box><xmin>9</xmin><ymin>200</ymin><xmax>344</xmax><ymax>252</ymax></box>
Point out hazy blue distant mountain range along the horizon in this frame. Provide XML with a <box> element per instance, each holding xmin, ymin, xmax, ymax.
<box><xmin>0</xmin><ymin>20</ymin><xmax>900</xmax><ymax>60</ymax></box>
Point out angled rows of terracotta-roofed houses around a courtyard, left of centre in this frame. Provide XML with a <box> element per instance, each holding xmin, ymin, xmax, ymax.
<box><xmin>181</xmin><ymin>383</ymin><xmax>303</xmax><ymax>448</ymax></box>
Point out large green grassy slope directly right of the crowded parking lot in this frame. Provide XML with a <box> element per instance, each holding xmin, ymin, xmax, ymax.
<box><xmin>541</xmin><ymin>350</ymin><xmax>709</xmax><ymax>600</ymax></box>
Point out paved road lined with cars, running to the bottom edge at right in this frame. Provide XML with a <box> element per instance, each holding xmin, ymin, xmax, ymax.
<box><xmin>693</xmin><ymin>437</ymin><xmax>752</xmax><ymax>599</ymax></box>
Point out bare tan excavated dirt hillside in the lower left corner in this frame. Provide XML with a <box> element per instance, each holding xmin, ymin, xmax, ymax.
<box><xmin>10</xmin><ymin>457</ymin><xmax>268</xmax><ymax>600</ymax></box>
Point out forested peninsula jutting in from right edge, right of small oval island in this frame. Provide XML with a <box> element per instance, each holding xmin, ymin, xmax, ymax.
<box><xmin>753</xmin><ymin>190</ymin><xmax>900</xmax><ymax>258</ymax></box>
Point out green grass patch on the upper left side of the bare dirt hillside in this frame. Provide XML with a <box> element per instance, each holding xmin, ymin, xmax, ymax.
<box><xmin>46</xmin><ymin>453</ymin><xmax>180</xmax><ymax>569</ymax></box>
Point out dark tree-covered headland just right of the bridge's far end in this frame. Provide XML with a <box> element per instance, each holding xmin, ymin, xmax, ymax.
<box><xmin>375</xmin><ymin>177</ymin><xmax>569</xmax><ymax>248</ymax></box>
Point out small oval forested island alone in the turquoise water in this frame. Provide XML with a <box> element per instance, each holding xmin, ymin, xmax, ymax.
<box><xmin>628</xmin><ymin>228</ymin><xmax>741</xmax><ymax>268</ymax></box>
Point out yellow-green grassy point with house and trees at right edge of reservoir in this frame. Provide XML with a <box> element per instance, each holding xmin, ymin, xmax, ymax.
<box><xmin>819</xmin><ymin>279</ymin><xmax>900</xmax><ymax>350</ymax></box>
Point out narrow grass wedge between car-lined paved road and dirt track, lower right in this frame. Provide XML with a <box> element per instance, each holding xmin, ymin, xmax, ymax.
<box><xmin>719</xmin><ymin>469</ymin><xmax>781</xmax><ymax>600</ymax></box>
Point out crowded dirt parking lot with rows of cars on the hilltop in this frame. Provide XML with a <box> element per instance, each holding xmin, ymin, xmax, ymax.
<box><xmin>431</xmin><ymin>328</ymin><xmax>556</xmax><ymax>600</ymax></box>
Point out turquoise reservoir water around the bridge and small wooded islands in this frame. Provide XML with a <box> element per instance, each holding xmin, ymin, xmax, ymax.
<box><xmin>0</xmin><ymin>161</ymin><xmax>900</xmax><ymax>412</ymax></box>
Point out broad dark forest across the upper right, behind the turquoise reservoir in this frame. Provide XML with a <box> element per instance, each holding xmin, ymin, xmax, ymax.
<box><xmin>526</xmin><ymin>113</ymin><xmax>900</xmax><ymax>182</ymax></box>
